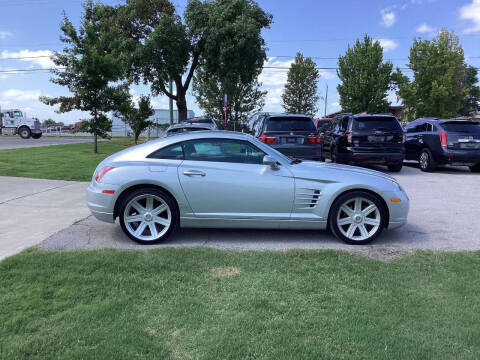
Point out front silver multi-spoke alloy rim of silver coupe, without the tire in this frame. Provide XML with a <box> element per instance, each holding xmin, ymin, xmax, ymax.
<box><xmin>337</xmin><ymin>197</ymin><xmax>381</xmax><ymax>241</ymax></box>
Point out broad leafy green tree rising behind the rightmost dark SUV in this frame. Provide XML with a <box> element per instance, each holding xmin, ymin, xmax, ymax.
<box><xmin>394</xmin><ymin>29</ymin><xmax>470</xmax><ymax>121</ymax></box>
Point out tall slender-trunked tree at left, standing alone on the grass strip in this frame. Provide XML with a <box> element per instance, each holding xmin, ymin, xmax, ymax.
<box><xmin>40</xmin><ymin>0</ymin><xmax>128</xmax><ymax>153</ymax></box>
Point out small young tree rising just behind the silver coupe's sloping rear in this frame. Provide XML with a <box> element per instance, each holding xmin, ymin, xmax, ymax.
<box><xmin>117</xmin><ymin>96</ymin><xmax>155</xmax><ymax>144</ymax></box>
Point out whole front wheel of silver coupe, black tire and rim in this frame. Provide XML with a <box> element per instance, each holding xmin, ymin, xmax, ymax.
<box><xmin>328</xmin><ymin>191</ymin><xmax>386</xmax><ymax>245</ymax></box>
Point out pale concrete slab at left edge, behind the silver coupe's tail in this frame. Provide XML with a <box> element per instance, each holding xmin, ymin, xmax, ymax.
<box><xmin>0</xmin><ymin>176</ymin><xmax>90</xmax><ymax>260</ymax></box>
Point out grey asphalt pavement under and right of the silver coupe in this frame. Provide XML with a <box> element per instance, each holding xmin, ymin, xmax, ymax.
<box><xmin>40</xmin><ymin>165</ymin><xmax>480</xmax><ymax>260</ymax></box>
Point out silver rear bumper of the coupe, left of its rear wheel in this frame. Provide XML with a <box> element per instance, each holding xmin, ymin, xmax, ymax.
<box><xmin>87</xmin><ymin>181</ymin><xmax>118</xmax><ymax>223</ymax></box>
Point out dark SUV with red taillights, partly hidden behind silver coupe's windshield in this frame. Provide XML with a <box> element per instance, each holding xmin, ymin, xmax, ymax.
<box><xmin>247</xmin><ymin>114</ymin><xmax>322</xmax><ymax>160</ymax></box>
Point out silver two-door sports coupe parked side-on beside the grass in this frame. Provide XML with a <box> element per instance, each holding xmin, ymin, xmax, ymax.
<box><xmin>87</xmin><ymin>131</ymin><xmax>409</xmax><ymax>244</ymax></box>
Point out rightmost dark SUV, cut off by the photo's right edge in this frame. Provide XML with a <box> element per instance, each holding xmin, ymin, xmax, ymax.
<box><xmin>405</xmin><ymin>118</ymin><xmax>480</xmax><ymax>172</ymax></box>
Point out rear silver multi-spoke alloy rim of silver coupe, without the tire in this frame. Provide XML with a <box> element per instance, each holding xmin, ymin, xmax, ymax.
<box><xmin>123</xmin><ymin>194</ymin><xmax>172</xmax><ymax>242</ymax></box>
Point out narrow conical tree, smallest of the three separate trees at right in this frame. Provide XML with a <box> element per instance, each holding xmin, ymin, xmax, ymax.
<box><xmin>282</xmin><ymin>53</ymin><xmax>320</xmax><ymax>116</ymax></box>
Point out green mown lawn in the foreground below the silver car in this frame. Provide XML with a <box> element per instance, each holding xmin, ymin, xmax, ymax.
<box><xmin>0</xmin><ymin>248</ymin><xmax>480</xmax><ymax>360</ymax></box>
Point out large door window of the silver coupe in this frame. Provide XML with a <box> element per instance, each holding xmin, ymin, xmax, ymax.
<box><xmin>183</xmin><ymin>139</ymin><xmax>265</xmax><ymax>164</ymax></box>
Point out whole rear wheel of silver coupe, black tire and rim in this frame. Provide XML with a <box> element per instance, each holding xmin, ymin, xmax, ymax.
<box><xmin>118</xmin><ymin>188</ymin><xmax>179</xmax><ymax>245</ymax></box>
